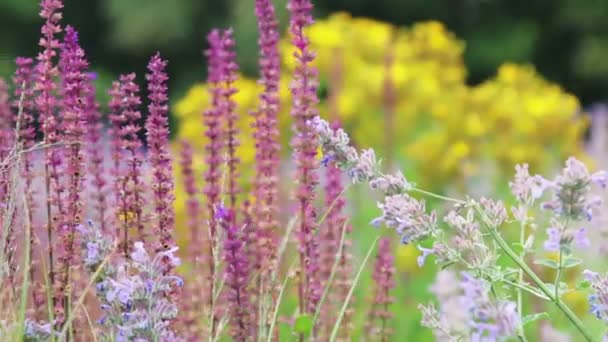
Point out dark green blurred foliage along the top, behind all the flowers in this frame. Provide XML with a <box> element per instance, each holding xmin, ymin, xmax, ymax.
<box><xmin>0</xmin><ymin>0</ymin><xmax>608</xmax><ymax>104</ymax></box>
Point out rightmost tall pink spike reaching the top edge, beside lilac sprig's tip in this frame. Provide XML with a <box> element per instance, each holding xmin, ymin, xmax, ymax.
<box><xmin>287</xmin><ymin>0</ymin><xmax>321</xmax><ymax>313</ymax></box>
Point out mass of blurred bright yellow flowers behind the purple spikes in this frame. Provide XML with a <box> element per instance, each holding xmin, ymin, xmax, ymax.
<box><xmin>175</xmin><ymin>13</ymin><xmax>586</xmax><ymax>189</ymax></box>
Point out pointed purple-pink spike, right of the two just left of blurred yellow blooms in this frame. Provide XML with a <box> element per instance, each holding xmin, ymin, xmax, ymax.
<box><xmin>146</xmin><ymin>54</ymin><xmax>175</xmax><ymax>256</ymax></box>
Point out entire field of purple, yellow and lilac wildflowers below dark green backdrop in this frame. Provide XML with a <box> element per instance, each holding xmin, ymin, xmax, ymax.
<box><xmin>0</xmin><ymin>0</ymin><xmax>608</xmax><ymax>342</ymax></box>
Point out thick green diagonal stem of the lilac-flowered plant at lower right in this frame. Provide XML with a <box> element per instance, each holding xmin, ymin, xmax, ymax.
<box><xmin>488</xmin><ymin>226</ymin><xmax>593</xmax><ymax>341</ymax></box>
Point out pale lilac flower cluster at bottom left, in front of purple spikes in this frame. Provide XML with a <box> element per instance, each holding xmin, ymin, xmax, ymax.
<box><xmin>88</xmin><ymin>241</ymin><xmax>183</xmax><ymax>341</ymax></box>
